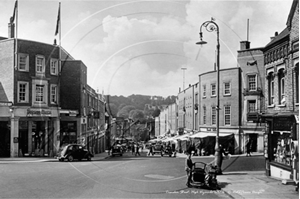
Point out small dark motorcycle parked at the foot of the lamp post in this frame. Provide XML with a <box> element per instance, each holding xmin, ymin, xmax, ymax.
<box><xmin>190</xmin><ymin>162</ymin><xmax>220</xmax><ymax>190</ymax></box>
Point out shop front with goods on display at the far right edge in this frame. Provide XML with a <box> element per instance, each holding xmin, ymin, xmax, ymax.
<box><xmin>264</xmin><ymin>114</ymin><xmax>298</xmax><ymax>179</ymax></box>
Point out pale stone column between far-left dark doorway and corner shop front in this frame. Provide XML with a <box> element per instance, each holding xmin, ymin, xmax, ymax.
<box><xmin>10</xmin><ymin>117</ymin><xmax>19</xmax><ymax>157</ymax></box>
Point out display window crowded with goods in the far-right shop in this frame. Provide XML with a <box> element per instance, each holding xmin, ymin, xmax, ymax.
<box><xmin>272</xmin><ymin>132</ymin><xmax>292</xmax><ymax>166</ymax></box>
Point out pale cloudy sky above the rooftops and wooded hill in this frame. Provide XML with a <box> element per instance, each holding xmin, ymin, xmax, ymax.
<box><xmin>0</xmin><ymin>0</ymin><xmax>292</xmax><ymax>97</ymax></box>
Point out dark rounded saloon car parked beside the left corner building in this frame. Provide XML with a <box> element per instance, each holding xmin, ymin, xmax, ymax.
<box><xmin>57</xmin><ymin>144</ymin><xmax>94</xmax><ymax>162</ymax></box>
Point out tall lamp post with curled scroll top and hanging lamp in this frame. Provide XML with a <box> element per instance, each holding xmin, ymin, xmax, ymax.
<box><xmin>196</xmin><ymin>18</ymin><xmax>222</xmax><ymax>174</ymax></box>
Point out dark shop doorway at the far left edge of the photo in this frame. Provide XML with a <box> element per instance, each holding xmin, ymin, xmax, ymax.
<box><xmin>0</xmin><ymin>122</ymin><xmax>10</xmax><ymax>157</ymax></box>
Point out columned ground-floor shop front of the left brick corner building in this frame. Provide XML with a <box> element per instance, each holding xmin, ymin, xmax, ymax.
<box><xmin>10</xmin><ymin>107</ymin><xmax>59</xmax><ymax>157</ymax></box>
